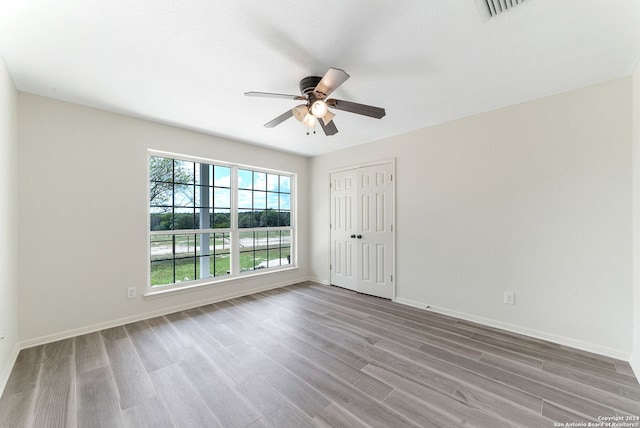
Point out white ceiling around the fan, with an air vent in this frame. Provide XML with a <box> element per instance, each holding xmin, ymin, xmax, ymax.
<box><xmin>0</xmin><ymin>0</ymin><xmax>640</xmax><ymax>156</ymax></box>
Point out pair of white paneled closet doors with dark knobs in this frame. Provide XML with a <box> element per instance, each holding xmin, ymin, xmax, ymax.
<box><xmin>331</xmin><ymin>164</ymin><xmax>394</xmax><ymax>299</ymax></box>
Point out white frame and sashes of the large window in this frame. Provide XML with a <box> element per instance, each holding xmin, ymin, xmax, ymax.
<box><xmin>145</xmin><ymin>149</ymin><xmax>298</xmax><ymax>297</ymax></box>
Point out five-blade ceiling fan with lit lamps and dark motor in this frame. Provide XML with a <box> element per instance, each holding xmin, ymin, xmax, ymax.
<box><xmin>244</xmin><ymin>68</ymin><xmax>386</xmax><ymax>135</ymax></box>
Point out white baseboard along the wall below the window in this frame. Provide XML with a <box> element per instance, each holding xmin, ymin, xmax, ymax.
<box><xmin>19</xmin><ymin>279</ymin><xmax>301</xmax><ymax>349</ymax></box>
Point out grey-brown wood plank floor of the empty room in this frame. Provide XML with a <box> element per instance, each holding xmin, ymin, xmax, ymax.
<box><xmin>0</xmin><ymin>282</ymin><xmax>640</xmax><ymax>428</ymax></box>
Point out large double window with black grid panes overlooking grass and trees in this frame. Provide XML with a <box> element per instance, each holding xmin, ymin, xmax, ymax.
<box><xmin>149</xmin><ymin>154</ymin><xmax>294</xmax><ymax>287</ymax></box>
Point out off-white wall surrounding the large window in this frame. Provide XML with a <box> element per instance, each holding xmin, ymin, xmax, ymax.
<box><xmin>18</xmin><ymin>93</ymin><xmax>309</xmax><ymax>345</ymax></box>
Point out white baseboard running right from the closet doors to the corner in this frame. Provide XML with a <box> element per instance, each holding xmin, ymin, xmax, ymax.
<box><xmin>394</xmin><ymin>297</ymin><xmax>639</xmax><ymax>362</ymax></box>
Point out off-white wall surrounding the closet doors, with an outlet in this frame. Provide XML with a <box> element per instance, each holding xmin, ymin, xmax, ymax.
<box><xmin>310</xmin><ymin>78</ymin><xmax>633</xmax><ymax>359</ymax></box>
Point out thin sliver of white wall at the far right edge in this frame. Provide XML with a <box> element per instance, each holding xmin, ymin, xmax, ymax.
<box><xmin>631</xmin><ymin>65</ymin><xmax>640</xmax><ymax>378</ymax></box>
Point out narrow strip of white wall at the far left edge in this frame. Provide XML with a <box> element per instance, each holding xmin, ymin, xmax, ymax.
<box><xmin>0</xmin><ymin>57</ymin><xmax>18</xmax><ymax>394</ymax></box>
